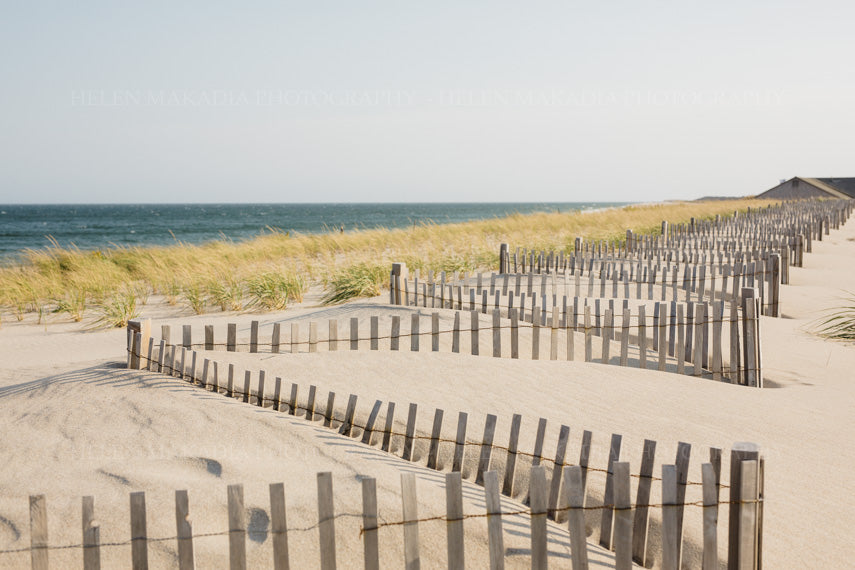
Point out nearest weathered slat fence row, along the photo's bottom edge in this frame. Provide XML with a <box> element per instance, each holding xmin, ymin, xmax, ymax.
<box><xmin>6</xmin><ymin>449</ymin><xmax>763</xmax><ymax>570</ymax></box>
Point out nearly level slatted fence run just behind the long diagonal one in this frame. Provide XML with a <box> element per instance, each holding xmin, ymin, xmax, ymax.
<box><xmin>128</xmin><ymin>291</ymin><xmax>762</xmax><ymax>387</ymax></box>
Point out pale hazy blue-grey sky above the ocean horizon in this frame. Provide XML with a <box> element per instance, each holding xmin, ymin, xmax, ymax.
<box><xmin>0</xmin><ymin>0</ymin><xmax>855</xmax><ymax>203</ymax></box>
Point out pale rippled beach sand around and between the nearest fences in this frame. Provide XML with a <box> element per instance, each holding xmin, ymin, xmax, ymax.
<box><xmin>0</xmin><ymin>215</ymin><xmax>855</xmax><ymax>568</ymax></box>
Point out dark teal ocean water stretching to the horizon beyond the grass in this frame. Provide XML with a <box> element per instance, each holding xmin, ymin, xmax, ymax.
<box><xmin>0</xmin><ymin>202</ymin><xmax>625</xmax><ymax>264</ymax></box>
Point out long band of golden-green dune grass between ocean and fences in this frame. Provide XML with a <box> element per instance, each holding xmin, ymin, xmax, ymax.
<box><xmin>0</xmin><ymin>199</ymin><xmax>775</xmax><ymax>326</ymax></box>
